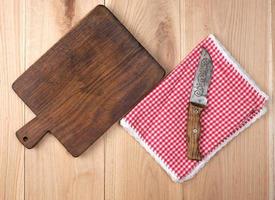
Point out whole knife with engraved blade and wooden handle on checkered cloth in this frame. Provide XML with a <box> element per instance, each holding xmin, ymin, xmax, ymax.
<box><xmin>187</xmin><ymin>48</ymin><xmax>213</xmax><ymax>160</ymax></box>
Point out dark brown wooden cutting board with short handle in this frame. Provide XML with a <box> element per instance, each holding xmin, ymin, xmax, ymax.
<box><xmin>13</xmin><ymin>6</ymin><xmax>165</xmax><ymax>156</ymax></box>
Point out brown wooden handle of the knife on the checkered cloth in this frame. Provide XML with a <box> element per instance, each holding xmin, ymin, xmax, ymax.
<box><xmin>187</xmin><ymin>103</ymin><xmax>203</xmax><ymax>160</ymax></box>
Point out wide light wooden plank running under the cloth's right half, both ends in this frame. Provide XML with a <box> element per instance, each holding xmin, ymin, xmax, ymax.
<box><xmin>180</xmin><ymin>0</ymin><xmax>270</xmax><ymax>200</ymax></box>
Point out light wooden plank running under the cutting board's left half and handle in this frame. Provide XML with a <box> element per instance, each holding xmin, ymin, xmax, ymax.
<box><xmin>25</xmin><ymin>0</ymin><xmax>104</xmax><ymax>200</ymax></box>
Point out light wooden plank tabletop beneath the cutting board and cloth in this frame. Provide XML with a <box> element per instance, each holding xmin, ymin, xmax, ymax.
<box><xmin>0</xmin><ymin>0</ymin><xmax>275</xmax><ymax>200</ymax></box>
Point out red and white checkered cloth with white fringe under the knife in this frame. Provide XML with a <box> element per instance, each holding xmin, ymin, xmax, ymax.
<box><xmin>120</xmin><ymin>35</ymin><xmax>268</xmax><ymax>182</ymax></box>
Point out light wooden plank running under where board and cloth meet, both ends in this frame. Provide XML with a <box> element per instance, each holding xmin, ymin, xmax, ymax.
<box><xmin>105</xmin><ymin>0</ymin><xmax>182</xmax><ymax>200</ymax></box>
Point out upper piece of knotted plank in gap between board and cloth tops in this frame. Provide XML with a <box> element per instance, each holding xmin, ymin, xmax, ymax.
<box><xmin>105</xmin><ymin>0</ymin><xmax>180</xmax><ymax>71</ymax></box>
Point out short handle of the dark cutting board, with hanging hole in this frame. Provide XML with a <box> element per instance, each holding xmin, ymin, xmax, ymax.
<box><xmin>16</xmin><ymin>116</ymin><xmax>50</xmax><ymax>149</ymax></box>
